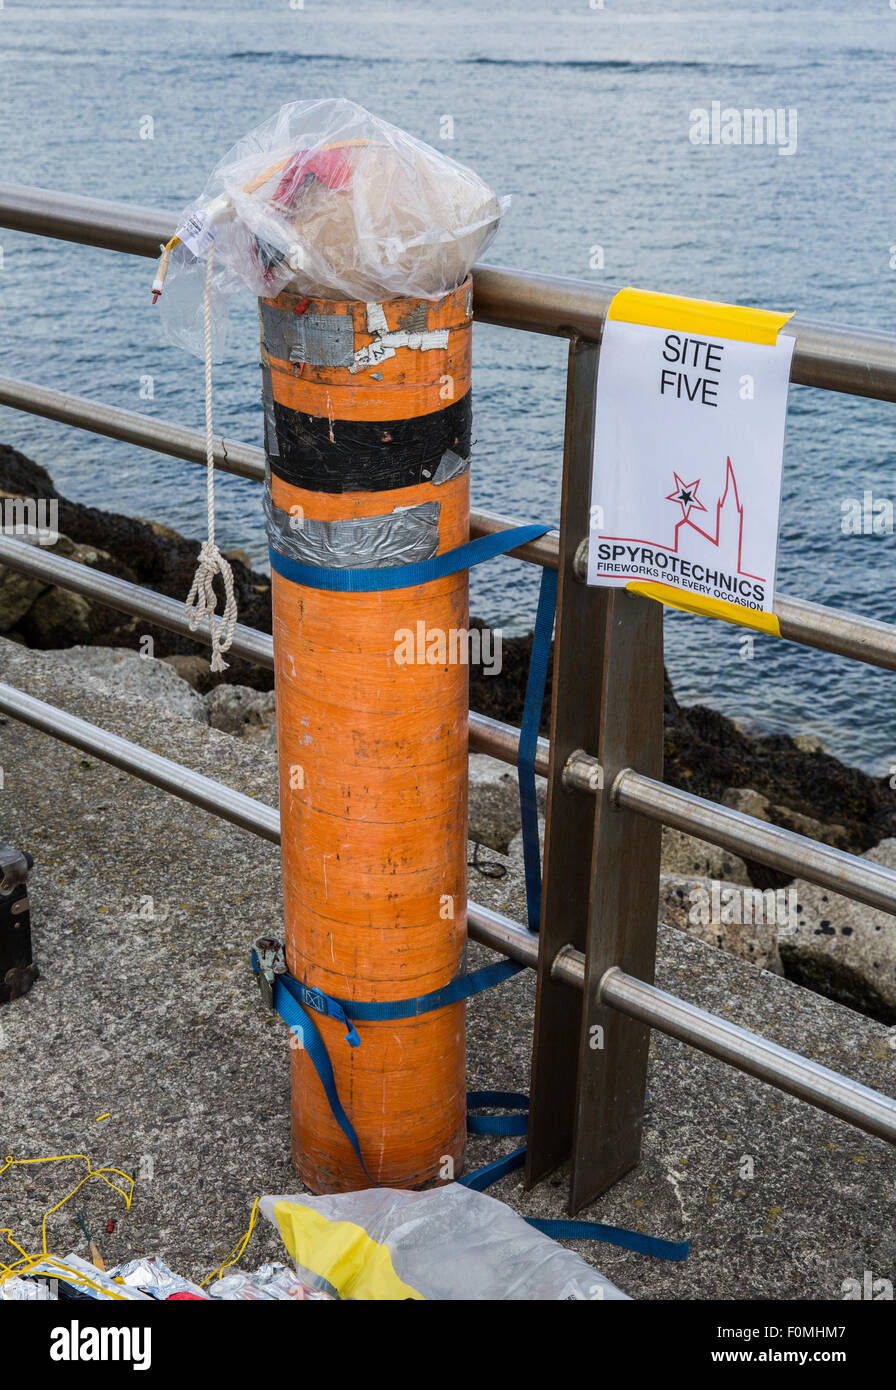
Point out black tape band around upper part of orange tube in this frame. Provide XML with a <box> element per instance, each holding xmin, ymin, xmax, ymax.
<box><xmin>268</xmin><ymin>391</ymin><xmax>472</xmax><ymax>492</ymax></box>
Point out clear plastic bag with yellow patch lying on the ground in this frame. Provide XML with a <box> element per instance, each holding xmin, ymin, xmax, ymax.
<box><xmin>258</xmin><ymin>1183</ymin><xmax>627</xmax><ymax>1301</ymax></box>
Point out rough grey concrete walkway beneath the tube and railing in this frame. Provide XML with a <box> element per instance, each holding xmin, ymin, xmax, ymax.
<box><xmin>0</xmin><ymin>639</ymin><xmax>896</xmax><ymax>1300</ymax></box>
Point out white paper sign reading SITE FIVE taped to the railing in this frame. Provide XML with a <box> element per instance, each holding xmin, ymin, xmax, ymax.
<box><xmin>588</xmin><ymin>318</ymin><xmax>793</xmax><ymax>621</ymax></box>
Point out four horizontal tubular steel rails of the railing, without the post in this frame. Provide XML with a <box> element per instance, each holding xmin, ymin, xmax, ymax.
<box><xmin>0</xmin><ymin>185</ymin><xmax>896</xmax><ymax>1162</ymax></box>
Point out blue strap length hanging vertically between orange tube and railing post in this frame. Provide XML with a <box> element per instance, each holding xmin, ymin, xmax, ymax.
<box><xmin>517</xmin><ymin>569</ymin><xmax>557</xmax><ymax>933</ymax></box>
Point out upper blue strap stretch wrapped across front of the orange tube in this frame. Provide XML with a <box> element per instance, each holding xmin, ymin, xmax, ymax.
<box><xmin>268</xmin><ymin>523</ymin><xmax>554</xmax><ymax>594</ymax></box>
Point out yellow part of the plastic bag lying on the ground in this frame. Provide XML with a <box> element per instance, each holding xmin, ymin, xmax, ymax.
<box><xmin>274</xmin><ymin>1202</ymin><xmax>424</xmax><ymax>1301</ymax></box>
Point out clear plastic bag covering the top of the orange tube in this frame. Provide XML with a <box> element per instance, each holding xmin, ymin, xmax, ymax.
<box><xmin>163</xmin><ymin>99</ymin><xmax>510</xmax><ymax>354</ymax></box>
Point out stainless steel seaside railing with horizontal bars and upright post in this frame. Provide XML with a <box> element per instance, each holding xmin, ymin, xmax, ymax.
<box><xmin>0</xmin><ymin>186</ymin><xmax>896</xmax><ymax>1209</ymax></box>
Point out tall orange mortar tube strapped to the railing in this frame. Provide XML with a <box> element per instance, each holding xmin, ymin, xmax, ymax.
<box><xmin>261</xmin><ymin>281</ymin><xmax>472</xmax><ymax>1193</ymax></box>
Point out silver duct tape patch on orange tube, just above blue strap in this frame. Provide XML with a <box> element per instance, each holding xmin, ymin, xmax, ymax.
<box><xmin>264</xmin><ymin>492</ymin><xmax>442</xmax><ymax>570</ymax></box>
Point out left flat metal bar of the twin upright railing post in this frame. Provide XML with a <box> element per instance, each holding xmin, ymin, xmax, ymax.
<box><xmin>525</xmin><ymin>338</ymin><xmax>608</xmax><ymax>1187</ymax></box>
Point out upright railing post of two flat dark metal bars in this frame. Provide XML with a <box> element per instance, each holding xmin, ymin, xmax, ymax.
<box><xmin>526</xmin><ymin>341</ymin><xmax>663</xmax><ymax>1211</ymax></box>
